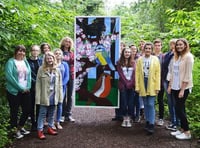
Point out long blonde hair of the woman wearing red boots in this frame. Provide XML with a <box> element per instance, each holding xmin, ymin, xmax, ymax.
<box><xmin>42</xmin><ymin>51</ymin><xmax>57</xmax><ymax>71</ymax></box>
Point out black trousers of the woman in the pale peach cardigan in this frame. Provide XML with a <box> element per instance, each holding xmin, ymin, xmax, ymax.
<box><xmin>172</xmin><ymin>89</ymin><xmax>189</xmax><ymax>131</ymax></box>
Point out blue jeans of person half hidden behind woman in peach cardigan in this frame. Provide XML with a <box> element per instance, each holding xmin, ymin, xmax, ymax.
<box><xmin>164</xmin><ymin>81</ymin><xmax>179</xmax><ymax>125</ymax></box>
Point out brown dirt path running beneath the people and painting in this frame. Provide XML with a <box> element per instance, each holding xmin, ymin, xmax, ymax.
<box><xmin>11</xmin><ymin>108</ymin><xmax>200</xmax><ymax>148</ymax></box>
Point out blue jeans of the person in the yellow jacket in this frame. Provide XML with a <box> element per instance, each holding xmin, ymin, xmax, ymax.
<box><xmin>142</xmin><ymin>96</ymin><xmax>156</xmax><ymax>124</ymax></box>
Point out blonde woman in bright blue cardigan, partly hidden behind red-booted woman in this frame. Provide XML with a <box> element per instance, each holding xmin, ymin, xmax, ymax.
<box><xmin>54</xmin><ymin>49</ymin><xmax>69</xmax><ymax>129</ymax></box>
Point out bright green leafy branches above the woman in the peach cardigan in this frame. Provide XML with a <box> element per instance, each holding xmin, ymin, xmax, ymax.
<box><xmin>166</xmin><ymin>5</ymin><xmax>200</xmax><ymax>57</ymax></box>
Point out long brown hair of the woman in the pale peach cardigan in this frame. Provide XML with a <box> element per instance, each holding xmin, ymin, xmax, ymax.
<box><xmin>174</xmin><ymin>38</ymin><xmax>190</xmax><ymax>60</ymax></box>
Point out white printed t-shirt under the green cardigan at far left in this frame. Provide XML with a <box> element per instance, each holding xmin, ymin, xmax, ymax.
<box><xmin>14</xmin><ymin>60</ymin><xmax>28</xmax><ymax>88</ymax></box>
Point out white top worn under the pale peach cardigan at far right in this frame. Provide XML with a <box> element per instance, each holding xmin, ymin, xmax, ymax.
<box><xmin>171</xmin><ymin>58</ymin><xmax>180</xmax><ymax>90</ymax></box>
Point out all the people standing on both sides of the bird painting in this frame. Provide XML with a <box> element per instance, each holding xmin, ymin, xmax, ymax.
<box><xmin>5</xmin><ymin>37</ymin><xmax>194</xmax><ymax>140</ymax></box>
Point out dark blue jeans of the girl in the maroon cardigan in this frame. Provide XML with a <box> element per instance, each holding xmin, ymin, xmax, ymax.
<box><xmin>120</xmin><ymin>89</ymin><xmax>134</xmax><ymax>117</ymax></box>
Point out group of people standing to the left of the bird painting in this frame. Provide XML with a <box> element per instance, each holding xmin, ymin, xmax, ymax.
<box><xmin>5</xmin><ymin>37</ymin><xmax>75</xmax><ymax>139</ymax></box>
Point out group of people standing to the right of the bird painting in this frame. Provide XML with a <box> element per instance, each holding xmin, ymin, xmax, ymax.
<box><xmin>113</xmin><ymin>38</ymin><xmax>194</xmax><ymax>140</ymax></box>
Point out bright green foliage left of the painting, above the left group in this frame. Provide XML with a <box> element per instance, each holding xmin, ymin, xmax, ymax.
<box><xmin>0</xmin><ymin>0</ymin><xmax>76</xmax><ymax>94</ymax></box>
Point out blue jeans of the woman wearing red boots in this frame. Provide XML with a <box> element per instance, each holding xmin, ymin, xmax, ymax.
<box><xmin>37</xmin><ymin>105</ymin><xmax>55</xmax><ymax>130</ymax></box>
